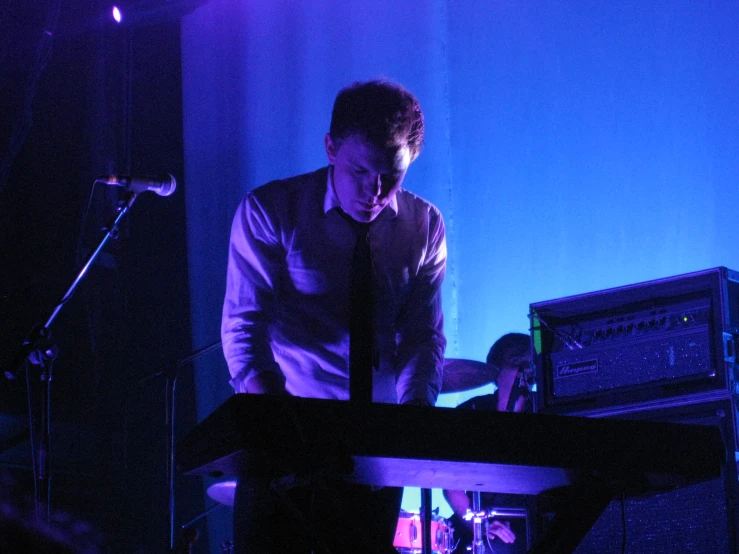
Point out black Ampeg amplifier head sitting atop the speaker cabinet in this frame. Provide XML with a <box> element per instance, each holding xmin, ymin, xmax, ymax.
<box><xmin>529</xmin><ymin>268</ymin><xmax>739</xmax><ymax>413</ymax></box>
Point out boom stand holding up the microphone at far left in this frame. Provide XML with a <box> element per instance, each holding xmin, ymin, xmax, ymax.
<box><xmin>5</xmin><ymin>192</ymin><xmax>138</xmax><ymax>521</ymax></box>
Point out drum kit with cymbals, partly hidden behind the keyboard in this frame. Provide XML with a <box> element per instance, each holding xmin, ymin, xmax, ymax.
<box><xmin>202</xmin><ymin>359</ymin><xmax>498</xmax><ymax>554</ymax></box>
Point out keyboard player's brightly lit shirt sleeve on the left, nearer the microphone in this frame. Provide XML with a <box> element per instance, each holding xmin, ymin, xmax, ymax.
<box><xmin>221</xmin><ymin>194</ymin><xmax>285</xmax><ymax>392</ymax></box>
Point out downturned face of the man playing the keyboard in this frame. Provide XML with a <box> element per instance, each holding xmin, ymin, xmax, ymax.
<box><xmin>325</xmin><ymin>134</ymin><xmax>410</xmax><ymax>223</ymax></box>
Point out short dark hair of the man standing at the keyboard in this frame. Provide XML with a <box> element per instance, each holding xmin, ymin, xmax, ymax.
<box><xmin>329</xmin><ymin>80</ymin><xmax>423</xmax><ymax>161</ymax></box>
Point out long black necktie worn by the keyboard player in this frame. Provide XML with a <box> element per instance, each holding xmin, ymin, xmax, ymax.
<box><xmin>349</xmin><ymin>220</ymin><xmax>374</xmax><ymax>403</ymax></box>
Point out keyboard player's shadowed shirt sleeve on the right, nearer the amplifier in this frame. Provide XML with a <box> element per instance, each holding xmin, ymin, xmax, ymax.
<box><xmin>396</xmin><ymin>208</ymin><xmax>447</xmax><ymax>406</ymax></box>
